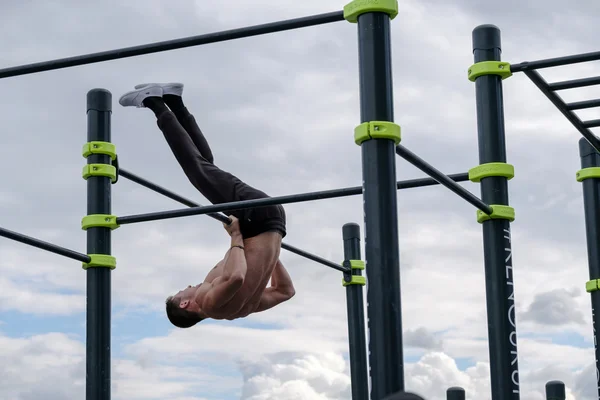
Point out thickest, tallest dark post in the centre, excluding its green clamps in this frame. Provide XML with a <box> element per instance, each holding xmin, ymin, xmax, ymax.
<box><xmin>358</xmin><ymin>8</ymin><xmax>404</xmax><ymax>400</ymax></box>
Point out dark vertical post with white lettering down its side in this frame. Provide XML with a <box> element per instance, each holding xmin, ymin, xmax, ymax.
<box><xmin>473</xmin><ymin>25</ymin><xmax>519</xmax><ymax>400</ymax></box>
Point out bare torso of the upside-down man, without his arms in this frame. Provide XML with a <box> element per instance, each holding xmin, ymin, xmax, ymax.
<box><xmin>204</xmin><ymin>232</ymin><xmax>282</xmax><ymax>320</ymax></box>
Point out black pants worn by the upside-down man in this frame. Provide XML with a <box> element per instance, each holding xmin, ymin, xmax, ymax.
<box><xmin>157</xmin><ymin>112</ymin><xmax>286</xmax><ymax>238</ymax></box>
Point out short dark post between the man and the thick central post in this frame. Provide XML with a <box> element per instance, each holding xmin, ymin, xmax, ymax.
<box><xmin>342</xmin><ymin>223</ymin><xmax>369</xmax><ymax>400</ymax></box>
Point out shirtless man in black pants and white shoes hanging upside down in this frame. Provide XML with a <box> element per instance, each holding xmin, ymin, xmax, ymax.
<box><xmin>119</xmin><ymin>83</ymin><xmax>295</xmax><ymax>328</ymax></box>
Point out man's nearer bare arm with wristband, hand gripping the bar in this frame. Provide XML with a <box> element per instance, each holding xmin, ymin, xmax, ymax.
<box><xmin>202</xmin><ymin>216</ymin><xmax>248</xmax><ymax>310</ymax></box>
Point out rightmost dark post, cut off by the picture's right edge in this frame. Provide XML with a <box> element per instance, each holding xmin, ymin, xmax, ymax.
<box><xmin>578</xmin><ymin>138</ymin><xmax>600</xmax><ymax>397</ymax></box>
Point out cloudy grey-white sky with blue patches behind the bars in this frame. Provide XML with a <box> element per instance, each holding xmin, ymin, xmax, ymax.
<box><xmin>0</xmin><ymin>0</ymin><xmax>600</xmax><ymax>400</ymax></box>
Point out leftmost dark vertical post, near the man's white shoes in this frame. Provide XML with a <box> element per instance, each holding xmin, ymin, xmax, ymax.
<box><xmin>86</xmin><ymin>89</ymin><xmax>112</xmax><ymax>400</ymax></box>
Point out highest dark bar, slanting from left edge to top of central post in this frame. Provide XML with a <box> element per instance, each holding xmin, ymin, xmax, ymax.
<box><xmin>0</xmin><ymin>11</ymin><xmax>344</xmax><ymax>79</ymax></box>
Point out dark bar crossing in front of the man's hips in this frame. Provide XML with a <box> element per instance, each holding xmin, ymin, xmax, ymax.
<box><xmin>117</xmin><ymin>169</ymin><xmax>474</xmax><ymax>225</ymax></box>
